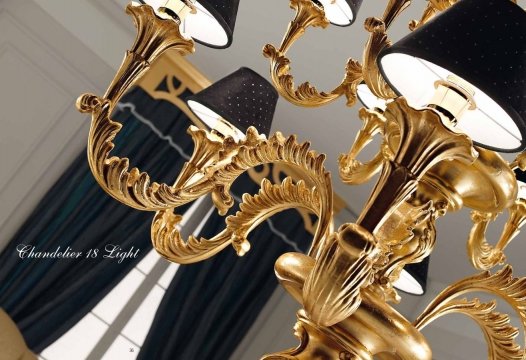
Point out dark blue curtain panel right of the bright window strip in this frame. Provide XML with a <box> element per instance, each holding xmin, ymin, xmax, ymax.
<box><xmin>138</xmin><ymin>176</ymin><xmax>312</xmax><ymax>360</ymax></box>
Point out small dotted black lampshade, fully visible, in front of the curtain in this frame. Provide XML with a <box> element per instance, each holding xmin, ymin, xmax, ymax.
<box><xmin>186</xmin><ymin>67</ymin><xmax>278</xmax><ymax>136</ymax></box>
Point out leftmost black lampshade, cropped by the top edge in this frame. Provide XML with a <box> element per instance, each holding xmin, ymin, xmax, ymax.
<box><xmin>140</xmin><ymin>0</ymin><xmax>239</xmax><ymax>49</ymax></box>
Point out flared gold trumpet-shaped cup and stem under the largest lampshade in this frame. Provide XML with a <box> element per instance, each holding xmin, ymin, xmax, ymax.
<box><xmin>357</xmin><ymin>98</ymin><xmax>477</xmax><ymax>233</ymax></box>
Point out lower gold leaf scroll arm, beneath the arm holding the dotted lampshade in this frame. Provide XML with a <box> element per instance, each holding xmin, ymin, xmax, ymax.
<box><xmin>152</xmin><ymin>177</ymin><xmax>326</xmax><ymax>264</ymax></box>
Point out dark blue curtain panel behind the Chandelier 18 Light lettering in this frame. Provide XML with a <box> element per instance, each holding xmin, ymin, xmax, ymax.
<box><xmin>0</xmin><ymin>89</ymin><xmax>193</xmax><ymax>353</ymax></box>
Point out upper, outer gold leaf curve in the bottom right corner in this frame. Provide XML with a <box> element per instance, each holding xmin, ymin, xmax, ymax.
<box><xmin>414</xmin><ymin>265</ymin><xmax>526</xmax><ymax>359</ymax></box>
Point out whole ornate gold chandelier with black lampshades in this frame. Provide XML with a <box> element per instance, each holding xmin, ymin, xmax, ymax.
<box><xmin>77</xmin><ymin>0</ymin><xmax>526</xmax><ymax>360</ymax></box>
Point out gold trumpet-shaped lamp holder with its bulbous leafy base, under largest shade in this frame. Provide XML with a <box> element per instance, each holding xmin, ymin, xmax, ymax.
<box><xmin>303</xmin><ymin>98</ymin><xmax>477</xmax><ymax>326</ymax></box>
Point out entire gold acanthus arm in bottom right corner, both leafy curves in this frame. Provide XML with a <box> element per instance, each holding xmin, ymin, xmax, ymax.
<box><xmin>414</xmin><ymin>265</ymin><xmax>526</xmax><ymax>360</ymax></box>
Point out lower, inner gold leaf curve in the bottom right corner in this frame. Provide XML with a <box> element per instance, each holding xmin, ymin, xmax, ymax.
<box><xmin>418</xmin><ymin>299</ymin><xmax>523</xmax><ymax>360</ymax></box>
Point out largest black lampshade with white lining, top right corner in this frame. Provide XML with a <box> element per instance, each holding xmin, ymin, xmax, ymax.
<box><xmin>378</xmin><ymin>0</ymin><xmax>526</xmax><ymax>152</ymax></box>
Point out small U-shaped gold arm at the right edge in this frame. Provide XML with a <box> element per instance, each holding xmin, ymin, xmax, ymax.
<box><xmin>468</xmin><ymin>199</ymin><xmax>526</xmax><ymax>270</ymax></box>
